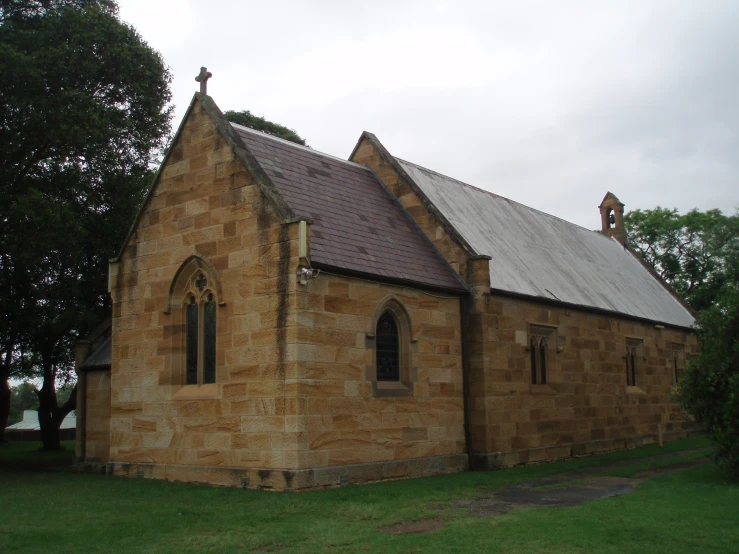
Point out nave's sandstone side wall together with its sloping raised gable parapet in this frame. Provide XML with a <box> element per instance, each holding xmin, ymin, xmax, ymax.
<box><xmin>352</xmin><ymin>136</ymin><xmax>697</xmax><ymax>467</ymax></box>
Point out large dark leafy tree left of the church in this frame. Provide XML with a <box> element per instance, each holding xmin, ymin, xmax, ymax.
<box><xmin>0</xmin><ymin>0</ymin><xmax>171</xmax><ymax>448</ymax></box>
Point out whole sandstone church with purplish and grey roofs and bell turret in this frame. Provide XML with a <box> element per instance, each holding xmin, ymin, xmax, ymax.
<box><xmin>76</xmin><ymin>80</ymin><xmax>697</xmax><ymax>490</ymax></box>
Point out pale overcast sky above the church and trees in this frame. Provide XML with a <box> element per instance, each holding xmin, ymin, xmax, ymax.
<box><xmin>119</xmin><ymin>0</ymin><xmax>739</xmax><ymax>229</ymax></box>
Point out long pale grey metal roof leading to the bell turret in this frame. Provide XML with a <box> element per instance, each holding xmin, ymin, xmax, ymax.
<box><xmin>396</xmin><ymin>158</ymin><xmax>694</xmax><ymax>327</ymax></box>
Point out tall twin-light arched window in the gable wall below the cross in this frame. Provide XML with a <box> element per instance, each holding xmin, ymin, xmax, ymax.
<box><xmin>165</xmin><ymin>256</ymin><xmax>222</xmax><ymax>385</ymax></box>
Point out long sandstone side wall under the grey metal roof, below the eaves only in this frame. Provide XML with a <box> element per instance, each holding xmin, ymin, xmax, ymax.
<box><xmin>472</xmin><ymin>296</ymin><xmax>698</xmax><ymax>467</ymax></box>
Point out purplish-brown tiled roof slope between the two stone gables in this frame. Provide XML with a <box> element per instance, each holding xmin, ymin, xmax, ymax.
<box><xmin>232</xmin><ymin>124</ymin><xmax>465</xmax><ymax>291</ymax></box>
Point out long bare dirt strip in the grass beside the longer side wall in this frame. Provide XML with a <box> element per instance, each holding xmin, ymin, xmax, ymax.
<box><xmin>431</xmin><ymin>446</ymin><xmax>708</xmax><ymax>517</ymax></box>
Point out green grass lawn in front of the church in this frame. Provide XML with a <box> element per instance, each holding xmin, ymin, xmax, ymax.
<box><xmin>0</xmin><ymin>437</ymin><xmax>739</xmax><ymax>553</ymax></box>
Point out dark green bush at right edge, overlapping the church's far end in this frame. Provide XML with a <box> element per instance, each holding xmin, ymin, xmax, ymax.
<box><xmin>677</xmin><ymin>287</ymin><xmax>739</xmax><ymax>479</ymax></box>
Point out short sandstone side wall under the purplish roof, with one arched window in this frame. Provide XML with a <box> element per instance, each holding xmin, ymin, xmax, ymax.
<box><xmin>287</xmin><ymin>272</ymin><xmax>466</xmax><ymax>485</ymax></box>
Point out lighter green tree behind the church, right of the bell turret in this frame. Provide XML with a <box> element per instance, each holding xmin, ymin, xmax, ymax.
<box><xmin>624</xmin><ymin>207</ymin><xmax>739</xmax><ymax>311</ymax></box>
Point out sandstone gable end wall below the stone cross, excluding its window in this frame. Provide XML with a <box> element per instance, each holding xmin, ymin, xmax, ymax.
<box><xmin>105</xmin><ymin>97</ymin><xmax>298</xmax><ymax>482</ymax></box>
